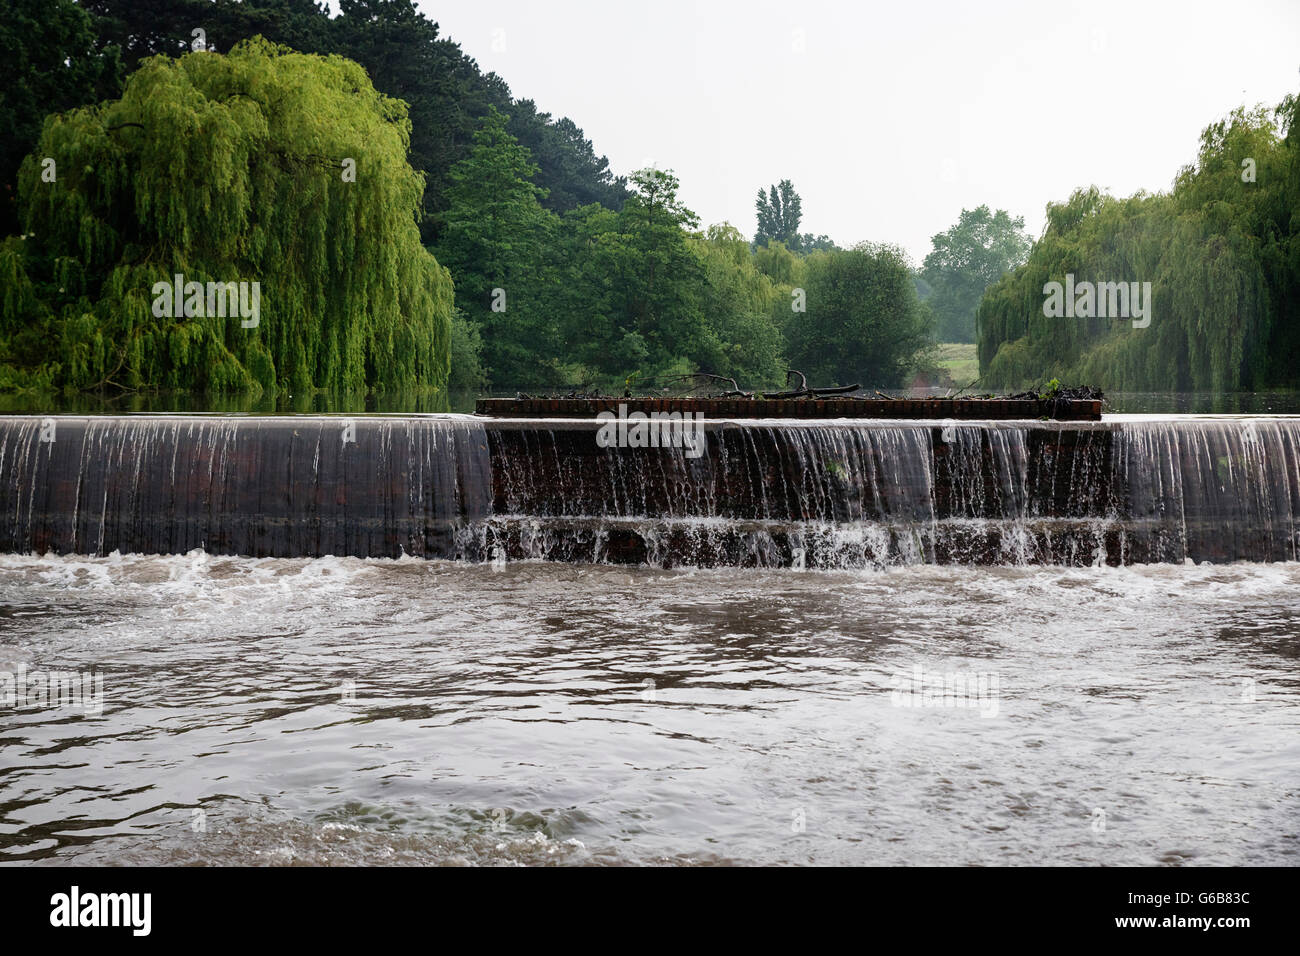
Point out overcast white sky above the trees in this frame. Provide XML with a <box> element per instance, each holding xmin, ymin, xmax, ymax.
<box><xmin>419</xmin><ymin>0</ymin><xmax>1300</xmax><ymax>264</ymax></box>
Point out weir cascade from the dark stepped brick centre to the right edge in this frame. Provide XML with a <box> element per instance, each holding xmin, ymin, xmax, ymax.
<box><xmin>488</xmin><ymin>418</ymin><xmax>1300</xmax><ymax>567</ymax></box>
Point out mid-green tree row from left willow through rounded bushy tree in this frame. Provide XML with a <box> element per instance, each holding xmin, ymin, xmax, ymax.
<box><xmin>433</xmin><ymin>109</ymin><xmax>930</xmax><ymax>389</ymax></box>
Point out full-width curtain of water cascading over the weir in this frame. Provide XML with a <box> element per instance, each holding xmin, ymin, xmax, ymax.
<box><xmin>0</xmin><ymin>416</ymin><xmax>1300</xmax><ymax>567</ymax></box>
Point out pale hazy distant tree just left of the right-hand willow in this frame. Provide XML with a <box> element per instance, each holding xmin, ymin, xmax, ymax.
<box><xmin>922</xmin><ymin>206</ymin><xmax>1031</xmax><ymax>342</ymax></box>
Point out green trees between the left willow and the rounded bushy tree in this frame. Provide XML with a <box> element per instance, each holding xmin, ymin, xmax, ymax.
<box><xmin>438</xmin><ymin>160</ymin><xmax>790</xmax><ymax>389</ymax></box>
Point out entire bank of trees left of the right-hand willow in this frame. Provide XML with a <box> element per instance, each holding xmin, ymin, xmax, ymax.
<box><xmin>0</xmin><ymin>0</ymin><xmax>1023</xmax><ymax>393</ymax></box>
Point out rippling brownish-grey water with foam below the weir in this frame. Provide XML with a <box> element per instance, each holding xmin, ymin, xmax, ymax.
<box><xmin>0</xmin><ymin>553</ymin><xmax>1300</xmax><ymax>865</ymax></box>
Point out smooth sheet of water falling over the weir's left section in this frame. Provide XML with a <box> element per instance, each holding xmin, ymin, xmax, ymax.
<box><xmin>0</xmin><ymin>418</ymin><xmax>490</xmax><ymax>558</ymax></box>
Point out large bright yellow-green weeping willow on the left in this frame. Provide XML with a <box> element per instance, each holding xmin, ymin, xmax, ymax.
<box><xmin>0</xmin><ymin>38</ymin><xmax>452</xmax><ymax>393</ymax></box>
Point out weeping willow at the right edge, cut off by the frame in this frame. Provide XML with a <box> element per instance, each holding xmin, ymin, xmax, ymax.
<box><xmin>976</xmin><ymin>98</ymin><xmax>1300</xmax><ymax>392</ymax></box>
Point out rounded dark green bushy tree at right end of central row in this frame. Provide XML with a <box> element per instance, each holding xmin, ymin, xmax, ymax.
<box><xmin>787</xmin><ymin>243</ymin><xmax>931</xmax><ymax>388</ymax></box>
